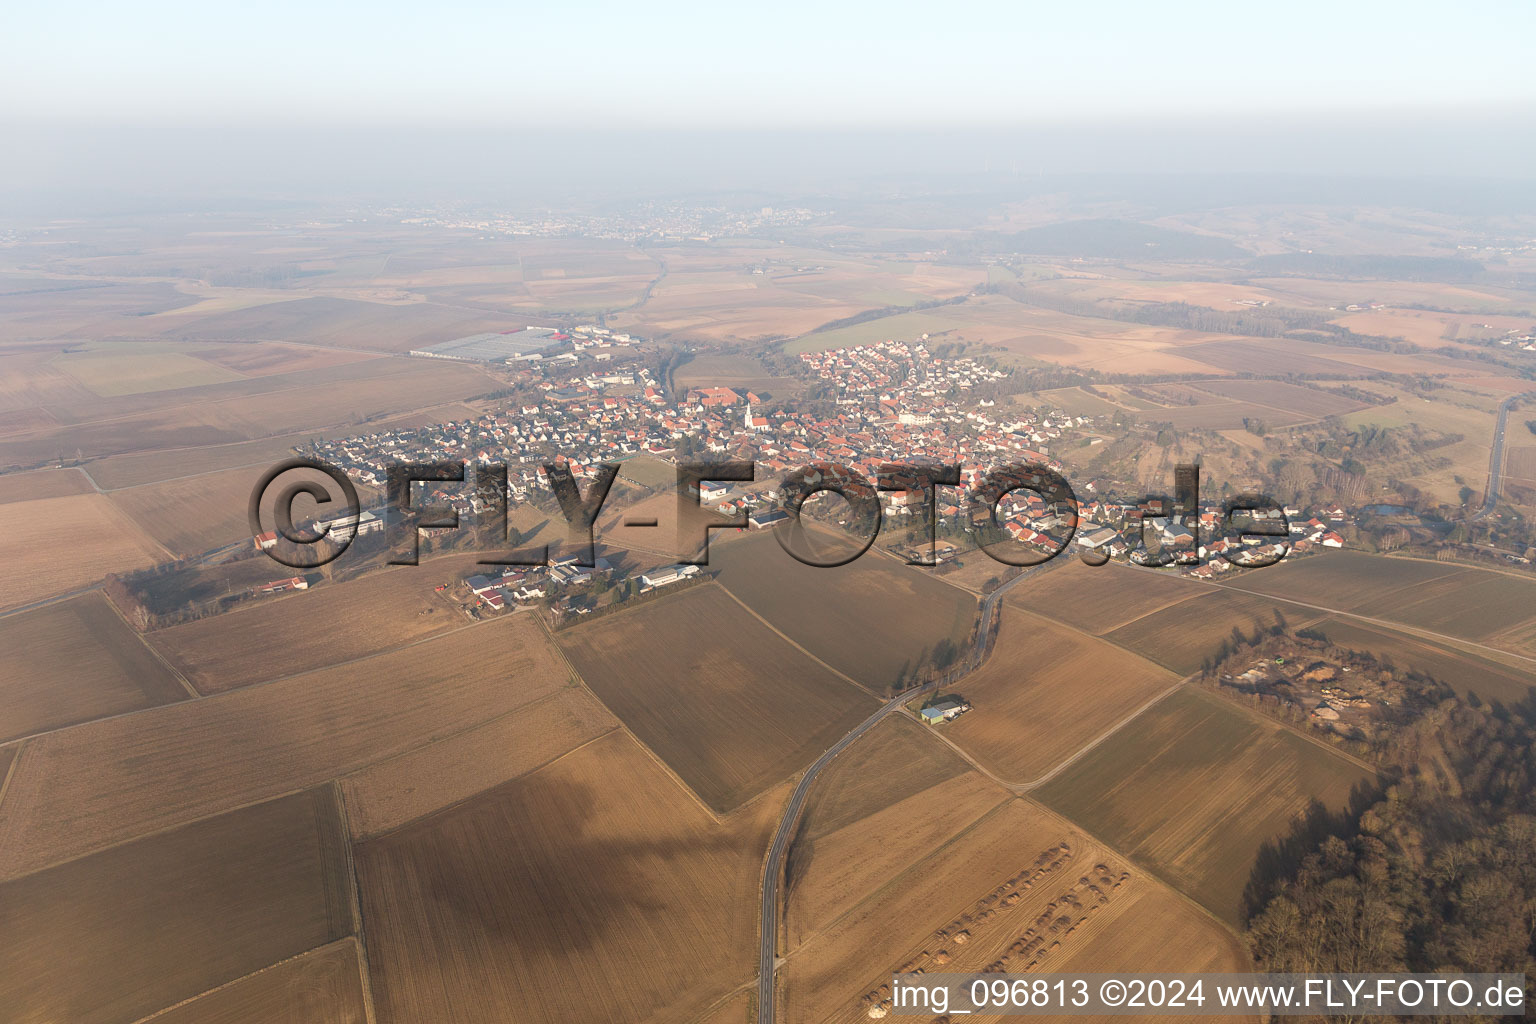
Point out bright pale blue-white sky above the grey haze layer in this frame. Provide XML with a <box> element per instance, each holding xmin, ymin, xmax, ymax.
<box><xmin>0</xmin><ymin>0</ymin><xmax>1536</xmax><ymax>127</ymax></box>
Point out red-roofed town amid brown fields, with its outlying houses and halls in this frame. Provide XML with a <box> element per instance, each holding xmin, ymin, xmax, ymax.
<box><xmin>293</xmin><ymin>324</ymin><xmax>1352</xmax><ymax>613</ymax></box>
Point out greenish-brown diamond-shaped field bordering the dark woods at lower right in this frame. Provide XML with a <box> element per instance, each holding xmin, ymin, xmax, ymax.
<box><xmin>1035</xmin><ymin>688</ymin><xmax>1373</xmax><ymax>926</ymax></box>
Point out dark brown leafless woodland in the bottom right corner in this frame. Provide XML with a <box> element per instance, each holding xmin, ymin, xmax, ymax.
<box><xmin>1247</xmin><ymin>632</ymin><xmax>1536</xmax><ymax>994</ymax></box>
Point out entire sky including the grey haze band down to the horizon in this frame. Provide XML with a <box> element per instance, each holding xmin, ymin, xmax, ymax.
<box><xmin>0</xmin><ymin>0</ymin><xmax>1536</xmax><ymax>213</ymax></box>
